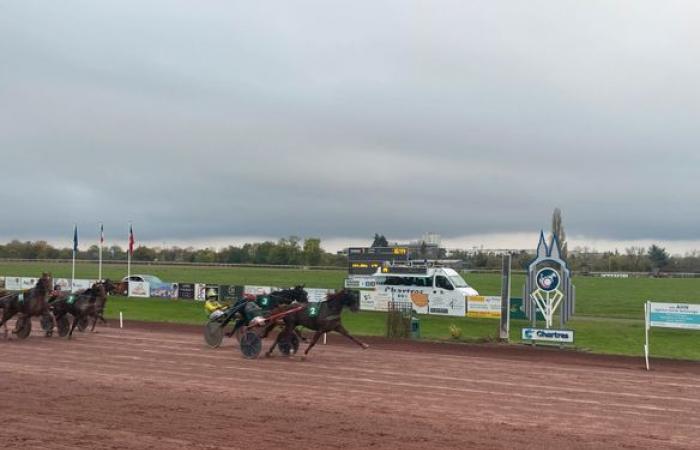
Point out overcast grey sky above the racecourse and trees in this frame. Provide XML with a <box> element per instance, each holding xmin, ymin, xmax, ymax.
<box><xmin>0</xmin><ymin>0</ymin><xmax>700</xmax><ymax>249</ymax></box>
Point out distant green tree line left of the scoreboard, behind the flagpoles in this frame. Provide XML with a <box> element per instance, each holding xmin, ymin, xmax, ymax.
<box><xmin>0</xmin><ymin>236</ymin><xmax>347</xmax><ymax>267</ymax></box>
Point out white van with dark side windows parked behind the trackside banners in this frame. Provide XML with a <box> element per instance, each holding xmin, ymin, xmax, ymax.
<box><xmin>346</xmin><ymin>266</ymin><xmax>479</xmax><ymax>316</ymax></box>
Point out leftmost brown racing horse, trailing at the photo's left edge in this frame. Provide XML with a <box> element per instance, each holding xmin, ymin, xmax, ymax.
<box><xmin>0</xmin><ymin>272</ymin><xmax>52</xmax><ymax>339</ymax></box>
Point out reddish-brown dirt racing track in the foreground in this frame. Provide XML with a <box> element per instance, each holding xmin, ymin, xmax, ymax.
<box><xmin>0</xmin><ymin>324</ymin><xmax>700</xmax><ymax>449</ymax></box>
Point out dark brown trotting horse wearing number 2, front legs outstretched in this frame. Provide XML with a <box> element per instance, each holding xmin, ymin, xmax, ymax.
<box><xmin>266</xmin><ymin>289</ymin><xmax>369</xmax><ymax>356</ymax></box>
